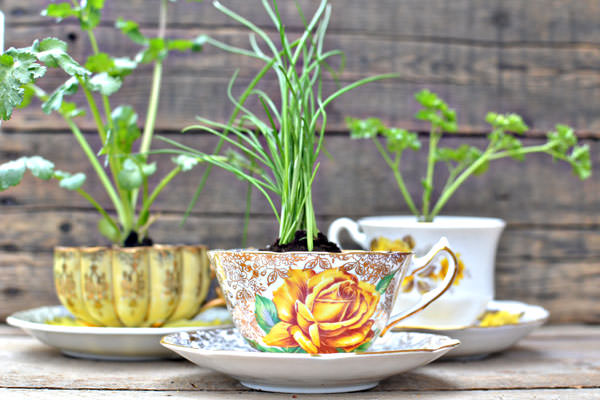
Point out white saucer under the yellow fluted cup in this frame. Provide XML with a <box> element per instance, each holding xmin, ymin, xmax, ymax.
<box><xmin>6</xmin><ymin>306</ymin><xmax>231</xmax><ymax>361</ymax></box>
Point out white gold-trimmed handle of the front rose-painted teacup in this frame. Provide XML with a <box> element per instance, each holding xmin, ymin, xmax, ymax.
<box><xmin>381</xmin><ymin>237</ymin><xmax>458</xmax><ymax>335</ymax></box>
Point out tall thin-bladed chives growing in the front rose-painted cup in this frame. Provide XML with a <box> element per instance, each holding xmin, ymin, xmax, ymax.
<box><xmin>164</xmin><ymin>0</ymin><xmax>390</xmax><ymax>251</ymax></box>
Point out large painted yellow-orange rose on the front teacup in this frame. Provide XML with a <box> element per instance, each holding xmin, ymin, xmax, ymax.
<box><xmin>263</xmin><ymin>269</ymin><xmax>380</xmax><ymax>354</ymax></box>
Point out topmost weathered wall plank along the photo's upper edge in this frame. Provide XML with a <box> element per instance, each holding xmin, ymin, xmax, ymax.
<box><xmin>7</xmin><ymin>0</ymin><xmax>600</xmax><ymax>45</ymax></box>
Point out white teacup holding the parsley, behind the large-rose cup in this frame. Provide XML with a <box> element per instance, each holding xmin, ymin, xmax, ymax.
<box><xmin>328</xmin><ymin>216</ymin><xmax>505</xmax><ymax>327</ymax></box>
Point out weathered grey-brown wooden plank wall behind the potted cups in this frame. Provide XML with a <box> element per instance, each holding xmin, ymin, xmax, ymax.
<box><xmin>0</xmin><ymin>0</ymin><xmax>600</xmax><ymax>323</ymax></box>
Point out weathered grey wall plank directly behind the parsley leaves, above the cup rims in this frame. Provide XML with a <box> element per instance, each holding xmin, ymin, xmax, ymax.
<box><xmin>0</xmin><ymin>134</ymin><xmax>600</xmax><ymax>225</ymax></box>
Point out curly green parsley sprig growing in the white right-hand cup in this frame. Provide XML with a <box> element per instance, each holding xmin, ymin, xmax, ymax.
<box><xmin>347</xmin><ymin>90</ymin><xmax>591</xmax><ymax>222</ymax></box>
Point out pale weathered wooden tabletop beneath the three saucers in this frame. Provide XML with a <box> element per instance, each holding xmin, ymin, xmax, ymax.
<box><xmin>0</xmin><ymin>326</ymin><xmax>600</xmax><ymax>398</ymax></box>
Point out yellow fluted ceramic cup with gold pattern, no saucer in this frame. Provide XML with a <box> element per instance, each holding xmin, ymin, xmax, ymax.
<box><xmin>54</xmin><ymin>245</ymin><xmax>217</xmax><ymax>327</ymax></box>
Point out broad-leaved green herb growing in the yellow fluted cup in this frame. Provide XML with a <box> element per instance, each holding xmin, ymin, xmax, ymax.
<box><xmin>0</xmin><ymin>0</ymin><xmax>204</xmax><ymax>245</ymax></box>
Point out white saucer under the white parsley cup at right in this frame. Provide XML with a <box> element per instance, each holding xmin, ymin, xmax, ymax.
<box><xmin>393</xmin><ymin>300</ymin><xmax>550</xmax><ymax>359</ymax></box>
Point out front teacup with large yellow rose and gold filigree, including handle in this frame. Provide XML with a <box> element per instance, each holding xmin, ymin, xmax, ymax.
<box><xmin>208</xmin><ymin>238</ymin><xmax>457</xmax><ymax>354</ymax></box>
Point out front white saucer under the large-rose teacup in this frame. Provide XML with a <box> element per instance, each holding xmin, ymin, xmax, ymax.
<box><xmin>161</xmin><ymin>328</ymin><xmax>460</xmax><ymax>393</ymax></box>
